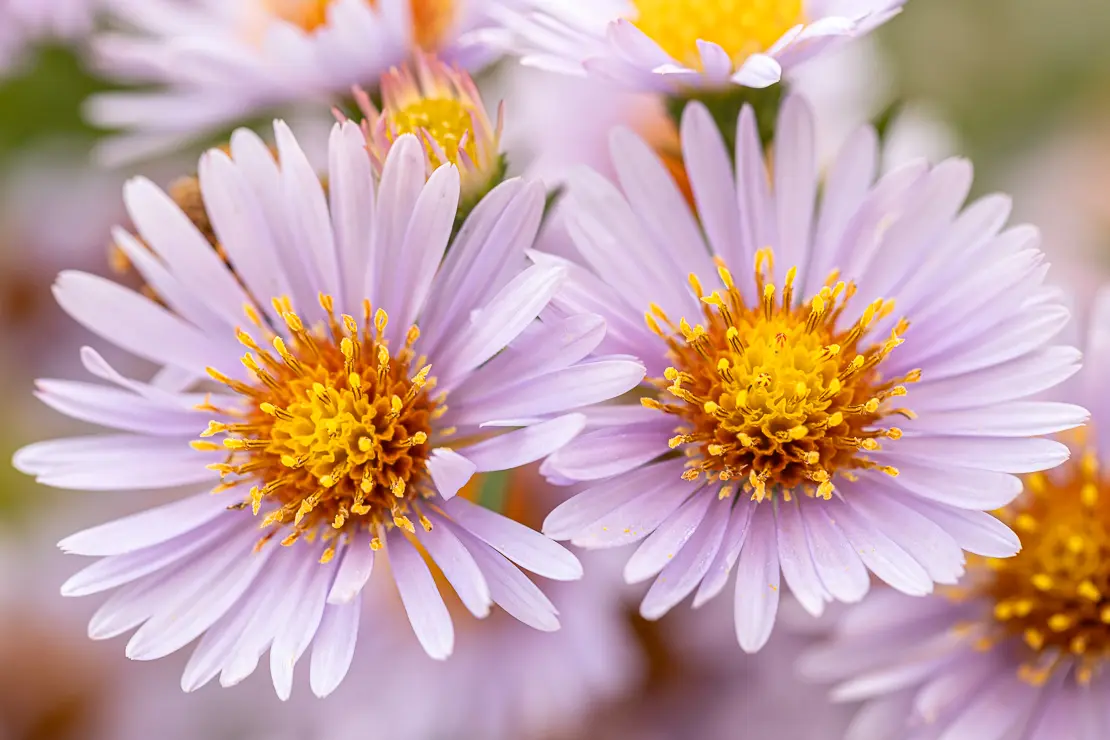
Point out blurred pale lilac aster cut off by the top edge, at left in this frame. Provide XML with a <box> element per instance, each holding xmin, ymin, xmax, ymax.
<box><xmin>88</xmin><ymin>0</ymin><xmax>503</xmax><ymax>161</ymax></box>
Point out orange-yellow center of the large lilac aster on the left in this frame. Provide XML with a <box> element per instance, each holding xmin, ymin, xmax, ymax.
<box><xmin>195</xmin><ymin>296</ymin><xmax>451</xmax><ymax>560</ymax></box>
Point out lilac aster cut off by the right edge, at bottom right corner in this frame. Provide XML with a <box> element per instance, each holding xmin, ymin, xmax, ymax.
<box><xmin>799</xmin><ymin>288</ymin><xmax>1110</xmax><ymax>740</ymax></box>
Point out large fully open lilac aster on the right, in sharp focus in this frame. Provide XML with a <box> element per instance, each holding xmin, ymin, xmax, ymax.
<box><xmin>535</xmin><ymin>97</ymin><xmax>1086</xmax><ymax>651</ymax></box>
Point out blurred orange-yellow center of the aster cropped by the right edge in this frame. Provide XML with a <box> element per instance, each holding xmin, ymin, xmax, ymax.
<box><xmin>971</xmin><ymin>453</ymin><xmax>1110</xmax><ymax>683</ymax></box>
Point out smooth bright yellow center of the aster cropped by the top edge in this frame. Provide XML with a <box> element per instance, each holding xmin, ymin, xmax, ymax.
<box><xmin>633</xmin><ymin>0</ymin><xmax>805</xmax><ymax>69</ymax></box>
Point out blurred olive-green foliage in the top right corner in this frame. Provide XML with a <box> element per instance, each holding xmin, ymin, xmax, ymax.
<box><xmin>880</xmin><ymin>0</ymin><xmax>1110</xmax><ymax>176</ymax></box>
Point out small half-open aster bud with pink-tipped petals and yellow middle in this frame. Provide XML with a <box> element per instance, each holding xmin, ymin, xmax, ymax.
<box><xmin>354</xmin><ymin>53</ymin><xmax>505</xmax><ymax>210</ymax></box>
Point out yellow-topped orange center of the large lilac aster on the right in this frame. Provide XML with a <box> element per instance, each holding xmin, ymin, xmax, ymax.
<box><xmin>642</xmin><ymin>250</ymin><xmax>920</xmax><ymax>501</ymax></box>
